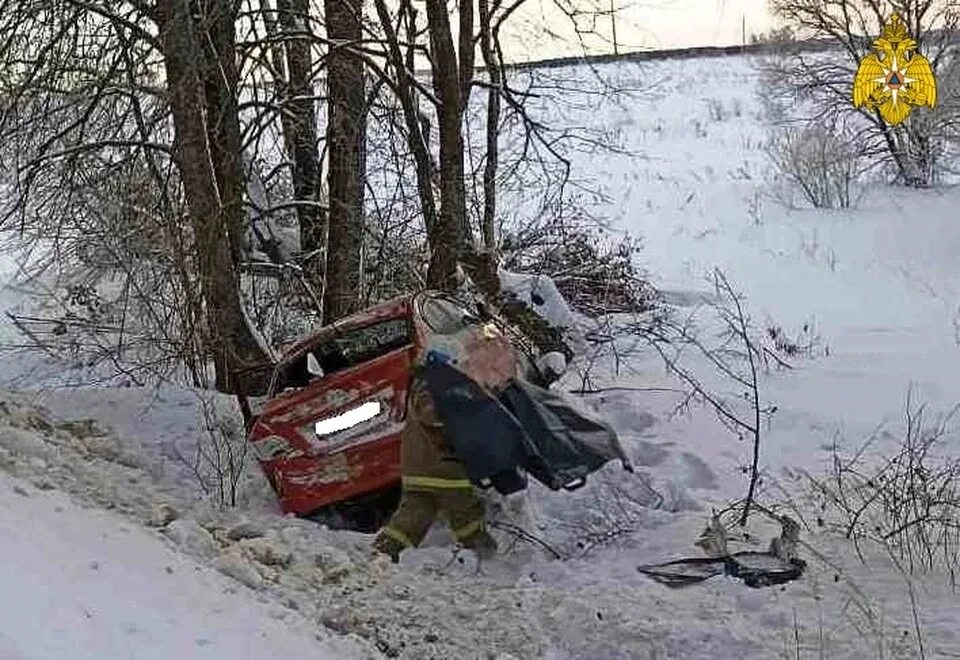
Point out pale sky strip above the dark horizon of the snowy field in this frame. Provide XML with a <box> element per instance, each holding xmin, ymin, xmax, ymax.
<box><xmin>505</xmin><ymin>0</ymin><xmax>772</xmax><ymax>60</ymax></box>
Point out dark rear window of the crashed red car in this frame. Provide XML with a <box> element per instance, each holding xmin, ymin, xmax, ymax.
<box><xmin>277</xmin><ymin>318</ymin><xmax>411</xmax><ymax>391</ymax></box>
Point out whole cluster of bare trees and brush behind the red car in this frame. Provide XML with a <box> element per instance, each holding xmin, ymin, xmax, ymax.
<box><xmin>0</xmin><ymin>0</ymin><xmax>624</xmax><ymax>391</ymax></box>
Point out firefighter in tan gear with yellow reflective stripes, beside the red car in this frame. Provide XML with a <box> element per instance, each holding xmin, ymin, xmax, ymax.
<box><xmin>374</xmin><ymin>366</ymin><xmax>497</xmax><ymax>563</ymax></box>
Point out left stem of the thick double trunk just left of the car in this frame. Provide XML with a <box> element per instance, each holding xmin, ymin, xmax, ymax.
<box><xmin>156</xmin><ymin>0</ymin><xmax>267</xmax><ymax>392</ymax></box>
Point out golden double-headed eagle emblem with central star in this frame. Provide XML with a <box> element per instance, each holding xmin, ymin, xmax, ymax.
<box><xmin>853</xmin><ymin>14</ymin><xmax>937</xmax><ymax>126</ymax></box>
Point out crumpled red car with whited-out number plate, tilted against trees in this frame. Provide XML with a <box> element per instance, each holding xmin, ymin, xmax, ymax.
<box><xmin>244</xmin><ymin>293</ymin><xmax>520</xmax><ymax>528</ymax></box>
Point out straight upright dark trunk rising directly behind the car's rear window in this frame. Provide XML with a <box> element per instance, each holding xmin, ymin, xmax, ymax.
<box><xmin>323</xmin><ymin>0</ymin><xmax>366</xmax><ymax>323</ymax></box>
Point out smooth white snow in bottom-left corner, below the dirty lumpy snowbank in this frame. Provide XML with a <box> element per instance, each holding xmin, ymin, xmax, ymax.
<box><xmin>0</xmin><ymin>466</ymin><xmax>368</xmax><ymax>660</ymax></box>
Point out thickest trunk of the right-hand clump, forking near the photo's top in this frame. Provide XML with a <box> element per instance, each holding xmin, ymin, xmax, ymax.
<box><xmin>427</xmin><ymin>0</ymin><xmax>473</xmax><ymax>290</ymax></box>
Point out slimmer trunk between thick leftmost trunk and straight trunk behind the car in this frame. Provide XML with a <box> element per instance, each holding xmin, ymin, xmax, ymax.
<box><xmin>277</xmin><ymin>0</ymin><xmax>325</xmax><ymax>282</ymax></box>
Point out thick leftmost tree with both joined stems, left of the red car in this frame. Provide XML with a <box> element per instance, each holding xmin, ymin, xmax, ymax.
<box><xmin>157</xmin><ymin>0</ymin><xmax>268</xmax><ymax>391</ymax></box>
